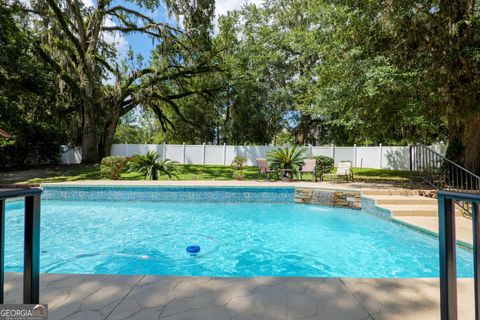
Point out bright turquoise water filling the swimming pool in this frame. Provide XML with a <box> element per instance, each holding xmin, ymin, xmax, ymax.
<box><xmin>5</xmin><ymin>200</ymin><xmax>473</xmax><ymax>278</ymax></box>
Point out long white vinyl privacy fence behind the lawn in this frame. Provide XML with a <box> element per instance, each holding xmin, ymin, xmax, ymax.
<box><xmin>62</xmin><ymin>143</ymin><xmax>445</xmax><ymax>170</ymax></box>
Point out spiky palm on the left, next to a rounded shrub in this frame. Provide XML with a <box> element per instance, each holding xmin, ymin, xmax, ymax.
<box><xmin>128</xmin><ymin>151</ymin><xmax>176</xmax><ymax>180</ymax></box>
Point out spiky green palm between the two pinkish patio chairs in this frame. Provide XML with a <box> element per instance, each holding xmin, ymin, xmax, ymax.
<box><xmin>267</xmin><ymin>146</ymin><xmax>307</xmax><ymax>178</ymax></box>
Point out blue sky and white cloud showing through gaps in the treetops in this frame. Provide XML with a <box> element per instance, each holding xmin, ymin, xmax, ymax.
<box><xmin>94</xmin><ymin>0</ymin><xmax>262</xmax><ymax>61</ymax></box>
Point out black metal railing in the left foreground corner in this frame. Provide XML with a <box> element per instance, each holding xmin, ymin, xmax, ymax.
<box><xmin>0</xmin><ymin>188</ymin><xmax>42</xmax><ymax>304</ymax></box>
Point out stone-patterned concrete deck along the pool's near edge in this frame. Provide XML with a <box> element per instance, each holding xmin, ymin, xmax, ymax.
<box><xmin>5</xmin><ymin>273</ymin><xmax>474</xmax><ymax>320</ymax></box>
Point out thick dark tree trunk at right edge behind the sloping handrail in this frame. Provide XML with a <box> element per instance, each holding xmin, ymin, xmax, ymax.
<box><xmin>447</xmin><ymin>111</ymin><xmax>480</xmax><ymax>174</ymax></box>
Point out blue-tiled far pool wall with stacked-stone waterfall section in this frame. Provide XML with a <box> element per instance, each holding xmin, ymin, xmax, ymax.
<box><xmin>42</xmin><ymin>184</ymin><xmax>368</xmax><ymax>209</ymax></box>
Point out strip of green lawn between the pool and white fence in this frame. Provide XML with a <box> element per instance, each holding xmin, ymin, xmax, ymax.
<box><xmin>0</xmin><ymin>164</ymin><xmax>409</xmax><ymax>185</ymax></box>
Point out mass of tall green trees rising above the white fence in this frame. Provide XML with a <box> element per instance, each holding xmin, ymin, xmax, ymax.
<box><xmin>0</xmin><ymin>0</ymin><xmax>480</xmax><ymax>172</ymax></box>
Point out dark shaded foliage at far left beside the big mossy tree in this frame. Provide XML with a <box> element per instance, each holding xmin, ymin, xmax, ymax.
<box><xmin>0</xmin><ymin>2</ymin><xmax>69</xmax><ymax>168</ymax></box>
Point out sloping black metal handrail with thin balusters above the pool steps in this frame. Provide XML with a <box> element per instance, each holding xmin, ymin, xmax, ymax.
<box><xmin>410</xmin><ymin>144</ymin><xmax>480</xmax><ymax>193</ymax></box>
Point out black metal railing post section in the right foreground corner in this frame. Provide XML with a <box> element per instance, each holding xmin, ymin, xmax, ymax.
<box><xmin>437</xmin><ymin>190</ymin><xmax>480</xmax><ymax>320</ymax></box>
